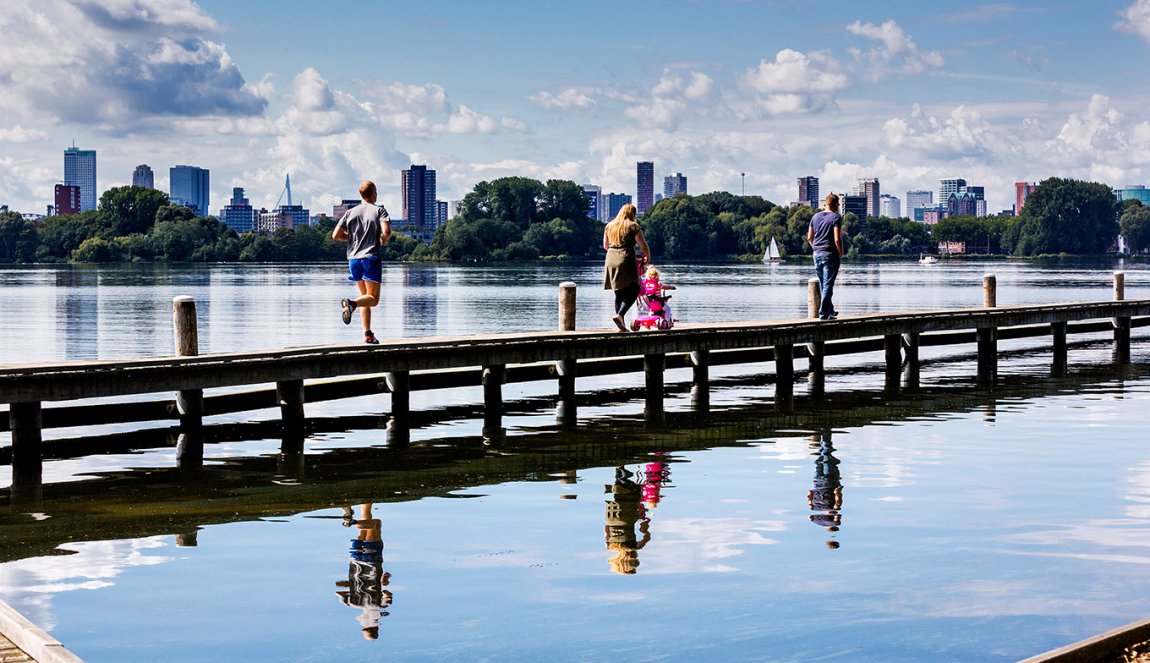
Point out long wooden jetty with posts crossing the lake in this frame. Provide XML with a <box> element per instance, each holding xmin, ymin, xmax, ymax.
<box><xmin>0</xmin><ymin>272</ymin><xmax>1150</xmax><ymax>491</ymax></box>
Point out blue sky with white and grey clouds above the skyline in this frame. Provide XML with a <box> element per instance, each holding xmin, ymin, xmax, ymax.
<box><xmin>0</xmin><ymin>0</ymin><xmax>1150</xmax><ymax>211</ymax></box>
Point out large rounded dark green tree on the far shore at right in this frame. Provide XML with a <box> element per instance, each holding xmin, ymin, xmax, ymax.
<box><xmin>1010</xmin><ymin>177</ymin><xmax>1119</xmax><ymax>255</ymax></box>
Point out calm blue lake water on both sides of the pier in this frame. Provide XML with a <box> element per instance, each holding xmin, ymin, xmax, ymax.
<box><xmin>0</xmin><ymin>262</ymin><xmax>1150</xmax><ymax>661</ymax></box>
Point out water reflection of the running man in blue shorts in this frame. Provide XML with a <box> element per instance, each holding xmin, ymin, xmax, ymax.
<box><xmin>336</xmin><ymin>503</ymin><xmax>391</xmax><ymax>640</ymax></box>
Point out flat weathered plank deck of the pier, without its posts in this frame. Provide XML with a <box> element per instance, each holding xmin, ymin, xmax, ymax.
<box><xmin>0</xmin><ymin>300</ymin><xmax>1150</xmax><ymax>403</ymax></box>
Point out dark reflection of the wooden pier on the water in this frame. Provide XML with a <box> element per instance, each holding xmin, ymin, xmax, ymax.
<box><xmin>0</xmin><ymin>367</ymin><xmax>1150</xmax><ymax>562</ymax></box>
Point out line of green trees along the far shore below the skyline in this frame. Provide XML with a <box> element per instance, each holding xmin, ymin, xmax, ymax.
<box><xmin>0</xmin><ymin>177</ymin><xmax>1150</xmax><ymax>263</ymax></box>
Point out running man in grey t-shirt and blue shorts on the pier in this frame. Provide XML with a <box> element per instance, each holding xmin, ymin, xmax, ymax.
<box><xmin>331</xmin><ymin>182</ymin><xmax>391</xmax><ymax>344</ymax></box>
